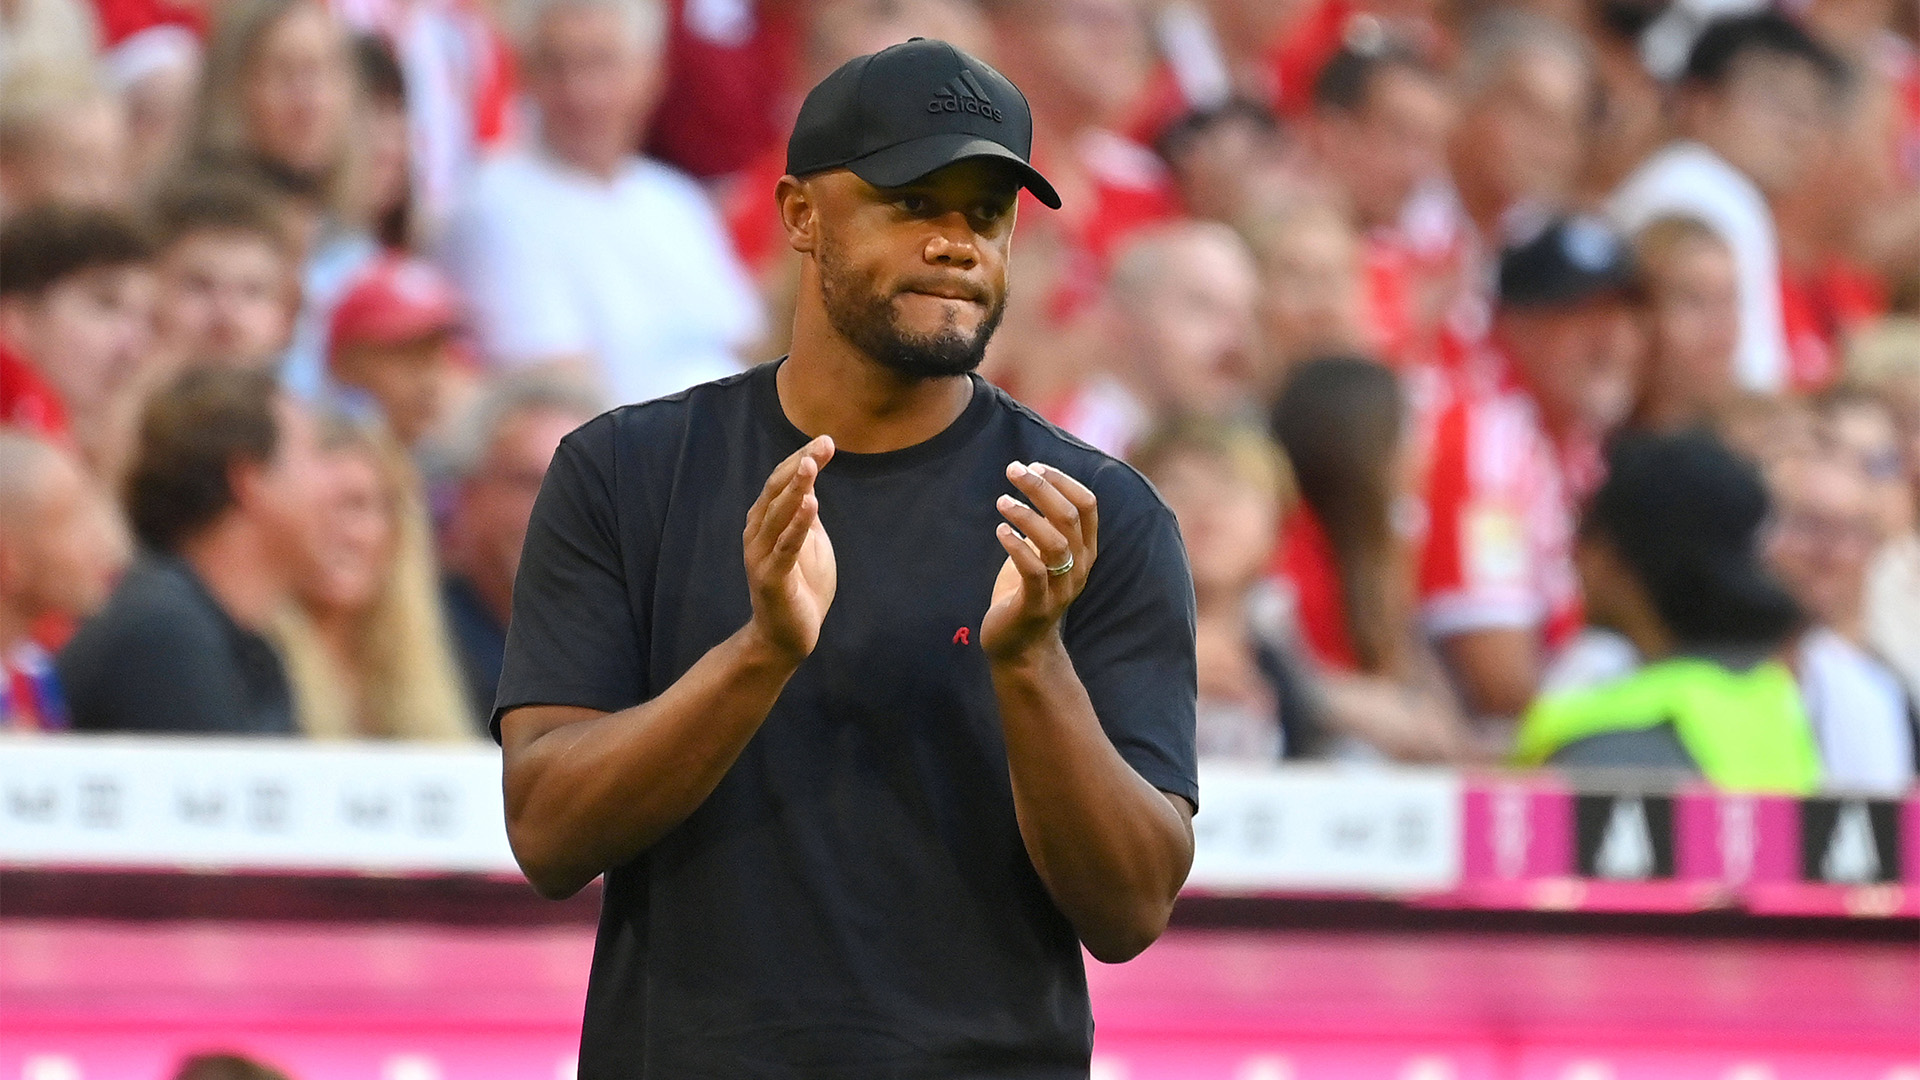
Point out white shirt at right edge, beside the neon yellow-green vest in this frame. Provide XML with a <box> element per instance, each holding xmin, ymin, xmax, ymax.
<box><xmin>1793</xmin><ymin>626</ymin><xmax>1914</xmax><ymax>794</ymax></box>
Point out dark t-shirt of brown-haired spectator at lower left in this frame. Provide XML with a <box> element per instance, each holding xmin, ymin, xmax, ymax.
<box><xmin>60</xmin><ymin>553</ymin><xmax>296</xmax><ymax>734</ymax></box>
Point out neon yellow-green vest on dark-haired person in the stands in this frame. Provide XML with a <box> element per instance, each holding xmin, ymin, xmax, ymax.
<box><xmin>1513</xmin><ymin>657</ymin><xmax>1820</xmax><ymax>796</ymax></box>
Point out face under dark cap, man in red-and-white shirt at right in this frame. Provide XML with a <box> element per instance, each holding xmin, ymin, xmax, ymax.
<box><xmin>1500</xmin><ymin>296</ymin><xmax>1644</xmax><ymax>432</ymax></box>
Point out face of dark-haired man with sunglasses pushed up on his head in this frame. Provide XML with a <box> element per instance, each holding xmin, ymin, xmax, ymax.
<box><xmin>1319</xmin><ymin>67</ymin><xmax>1453</xmax><ymax>227</ymax></box>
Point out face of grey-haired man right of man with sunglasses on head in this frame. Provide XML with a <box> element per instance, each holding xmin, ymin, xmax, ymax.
<box><xmin>1453</xmin><ymin>50</ymin><xmax>1594</xmax><ymax>206</ymax></box>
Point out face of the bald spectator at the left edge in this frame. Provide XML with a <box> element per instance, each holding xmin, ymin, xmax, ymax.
<box><xmin>0</xmin><ymin>447</ymin><xmax>127</xmax><ymax>619</ymax></box>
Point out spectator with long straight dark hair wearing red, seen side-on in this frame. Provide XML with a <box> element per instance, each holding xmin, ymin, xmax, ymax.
<box><xmin>1273</xmin><ymin>357</ymin><xmax>1469</xmax><ymax>761</ymax></box>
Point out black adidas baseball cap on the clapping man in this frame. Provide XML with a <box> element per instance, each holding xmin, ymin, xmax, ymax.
<box><xmin>787</xmin><ymin>38</ymin><xmax>1060</xmax><ymax>209</ymax></box>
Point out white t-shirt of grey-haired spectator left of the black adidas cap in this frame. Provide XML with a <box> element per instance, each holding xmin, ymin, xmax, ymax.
<box><xmin>442</xmin><ymin>150</ymin><xmax>764</xmax><ymax>402</ymax></box>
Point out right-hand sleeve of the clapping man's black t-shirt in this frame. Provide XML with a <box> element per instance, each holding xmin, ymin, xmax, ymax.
<box><xmin>1064</xmin><ymin>463</ymin><xmax>1200</xmax><ymax>807</ymax></box>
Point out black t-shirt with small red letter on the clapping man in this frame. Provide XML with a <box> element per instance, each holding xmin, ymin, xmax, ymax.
<box><xmin>493</xmin><ymin>365</ymin><xmax>1198</xmax><ymax>1080</ymax></box>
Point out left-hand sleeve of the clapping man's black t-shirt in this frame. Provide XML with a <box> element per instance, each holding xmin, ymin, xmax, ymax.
<box><xmin>488</xmin><ymin>417</ymin><xmax>647</xmax><ymax>740</ymax></box>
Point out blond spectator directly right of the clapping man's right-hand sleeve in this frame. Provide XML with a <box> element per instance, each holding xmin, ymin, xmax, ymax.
<box><xmin>1133</xmin><ymin>411</ymin><xmax>1323</xmax><ymax>761</ymax></box>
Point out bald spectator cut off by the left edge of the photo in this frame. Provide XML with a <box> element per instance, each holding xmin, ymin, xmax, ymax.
<box><xmin>0</xmin><ymin>427</ymin><xmax>123</xmax><ymax>730</ymax></box>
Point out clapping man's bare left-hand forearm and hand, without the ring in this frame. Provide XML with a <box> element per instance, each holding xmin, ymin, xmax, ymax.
<box><xmin>501</xmin><ymin>438</ymin><xmax>837</xmax><ymax>897</ymax></box>
